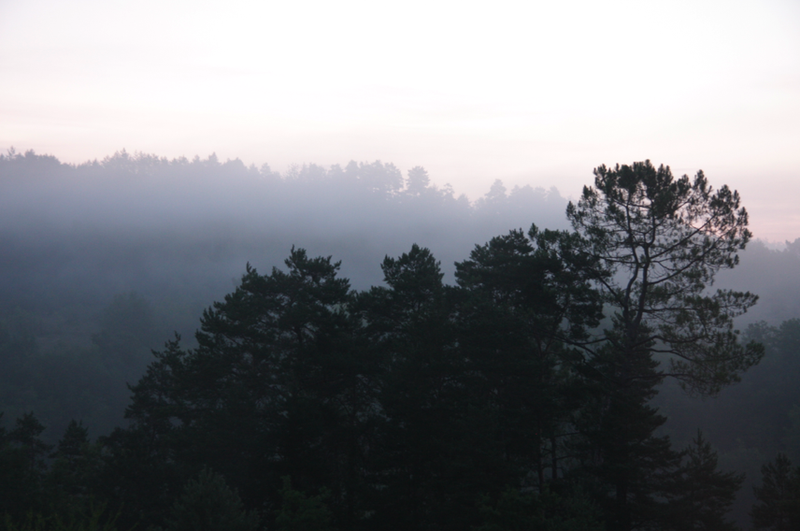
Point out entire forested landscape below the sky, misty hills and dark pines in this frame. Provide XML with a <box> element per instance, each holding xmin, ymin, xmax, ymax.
<box><xmin>0</xmin><ymin>151</ymin><xmax>800</xmax><ymax>531</ymax></box>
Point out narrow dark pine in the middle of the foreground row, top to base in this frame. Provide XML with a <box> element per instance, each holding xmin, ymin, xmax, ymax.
<box><xmin>354</xmin><ymin>245</ymin><xmax>482</xmax><ymax>529</ymax></box>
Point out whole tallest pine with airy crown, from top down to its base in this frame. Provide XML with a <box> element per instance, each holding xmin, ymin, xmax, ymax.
<box><xmin>567</xmin><ymin>161</ymin><xmax>763</xmax><ymax>531</ymax></box>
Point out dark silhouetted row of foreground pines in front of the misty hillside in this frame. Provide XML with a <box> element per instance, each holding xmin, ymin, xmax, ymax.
<box><xmin>0</xmin><ymin>162</ymin><xmax>800</xmax><ymax>531</ymax></box>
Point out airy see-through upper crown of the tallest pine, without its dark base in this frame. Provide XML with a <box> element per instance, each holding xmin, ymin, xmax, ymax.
<box><xmin>567</xmin><ymin>161</ymin><xmax>763</xmax><ymax>395</ymax></box>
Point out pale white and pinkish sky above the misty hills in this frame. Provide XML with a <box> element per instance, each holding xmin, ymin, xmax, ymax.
<box><xmin>0</xmin><ymin>0</ymin><xmax>800</xmax><ymax>243</ymax></box>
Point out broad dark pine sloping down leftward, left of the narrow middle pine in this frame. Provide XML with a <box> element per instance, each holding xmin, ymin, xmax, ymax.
<box><xmin>119</xmin><ymin>249</ymin><xmax>373</xmax><ymax>519</ymax></box>
